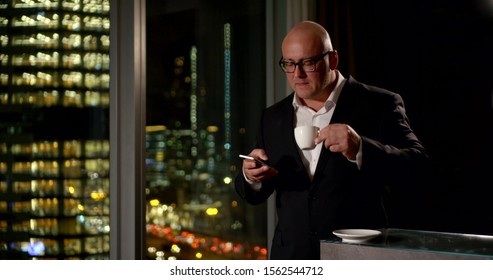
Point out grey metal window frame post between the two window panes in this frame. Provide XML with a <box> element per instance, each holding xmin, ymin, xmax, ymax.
<box><xmin>110</xmin><ymin>0</ymin><xmax>146</xmax><ymax>260</ymax></box>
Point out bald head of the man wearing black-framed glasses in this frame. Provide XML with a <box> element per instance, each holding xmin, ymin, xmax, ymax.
<box><xmin>280</xmin><ymin>21</ymin><xmax>338</xmax><ymax>105</ymax></box>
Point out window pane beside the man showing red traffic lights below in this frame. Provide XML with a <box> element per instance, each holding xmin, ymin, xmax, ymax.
<box><xmin>146</xmin><ymin>0</ymin><xmax>267</xmax><ymax>259</ymax></box>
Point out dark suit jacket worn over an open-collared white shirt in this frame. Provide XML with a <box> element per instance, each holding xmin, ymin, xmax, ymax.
<box><xmin>235</xmin><ymin>77</ymin><xmax>427</xmax><ymax>259</ymax></box>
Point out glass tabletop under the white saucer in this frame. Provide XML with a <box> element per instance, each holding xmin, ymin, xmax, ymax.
<box><xmin>321</xmin><ymin>228</ymin><xmax>493</xmax><ymax>258</ymax></box>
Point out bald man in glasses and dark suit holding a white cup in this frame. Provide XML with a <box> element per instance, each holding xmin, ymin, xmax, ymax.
<box><xmin>235</xmin><ymin>21</ymin><xmax>428</xmax><ymax>259</ymax></box>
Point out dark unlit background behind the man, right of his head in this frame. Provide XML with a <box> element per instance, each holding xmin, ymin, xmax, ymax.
<box><xmin>317</xmin><ymin>0</ymin><xmax>493</xmax><ymax>234</ymax></box>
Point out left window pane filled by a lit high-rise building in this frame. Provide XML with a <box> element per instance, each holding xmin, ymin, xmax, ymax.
<box><xmin>0</xmin><ymin>0</ymin><xmax>110</xmax><ymax>259</ymax></box>
